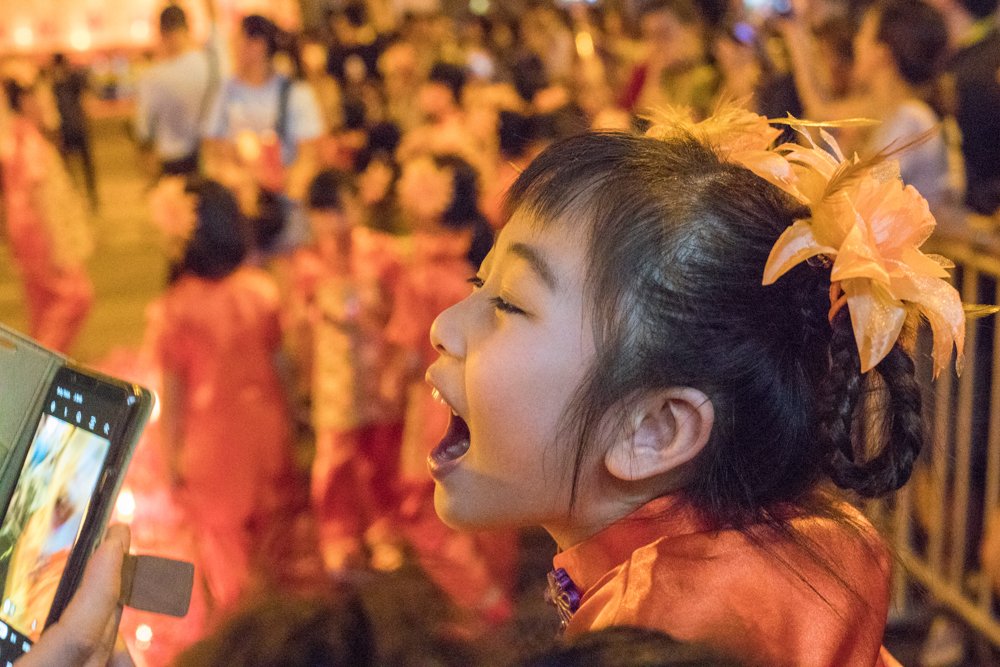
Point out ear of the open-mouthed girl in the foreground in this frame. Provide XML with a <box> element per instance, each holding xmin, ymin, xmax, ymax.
<box><xmin>604</xmin><ymin>387</ymin><xmax>715</xmax><ymax>482</ymax></box>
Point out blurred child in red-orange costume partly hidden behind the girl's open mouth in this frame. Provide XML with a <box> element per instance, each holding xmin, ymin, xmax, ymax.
<box><xmin>385</xmin><ymin>155</ymin><xmax>514</xmax><ymax>622</ymax></box>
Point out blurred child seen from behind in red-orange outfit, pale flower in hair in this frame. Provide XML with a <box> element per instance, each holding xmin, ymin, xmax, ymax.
<box><xmin>147</xmin><ymin>177</ymin><xmax>290</xmax><ymax>611</ymax></box>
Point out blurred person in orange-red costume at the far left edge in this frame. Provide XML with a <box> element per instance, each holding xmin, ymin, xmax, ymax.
<box><xmin>0</xmin><ymin>80</ymin><xmax>94</xmax><ymax>352</ymax></box>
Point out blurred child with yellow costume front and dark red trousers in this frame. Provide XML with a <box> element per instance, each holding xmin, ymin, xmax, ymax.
<box><xmin>289</xmin><ymin>170</ymin><xmax>403</xmax><ymax>569</ymax></box>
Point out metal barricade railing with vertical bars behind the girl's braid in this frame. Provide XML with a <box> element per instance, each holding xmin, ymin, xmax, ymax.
<box><xmin>870</xmin><ymin>218</ymin><xmax>1000</xmax><ymax>646</ymax></box>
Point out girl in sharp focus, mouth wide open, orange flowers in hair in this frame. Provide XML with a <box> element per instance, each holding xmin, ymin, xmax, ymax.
<box><xmin>427</xmin><ymin>111</ymin><xmax>964</xmax><ymax>666</ymax></box>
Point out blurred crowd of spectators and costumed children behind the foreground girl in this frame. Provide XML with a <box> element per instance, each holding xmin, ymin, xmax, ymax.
<box><xmin>0</xmin><ymin>0</ymin><xmax>1000</xmax><ymax>664</ymax></box>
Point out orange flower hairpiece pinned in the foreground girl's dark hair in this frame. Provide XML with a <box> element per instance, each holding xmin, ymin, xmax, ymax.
<box><xmin>648</xmin><ymin>106</ymin><xmax>980</xmax><ymax>376</ymax></box>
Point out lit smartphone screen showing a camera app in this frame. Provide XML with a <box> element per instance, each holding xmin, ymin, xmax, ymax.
<box><xmin>0</xmin><ymin>383</ymin><xmax>112</xmax><ymax>650</ymax></box>
